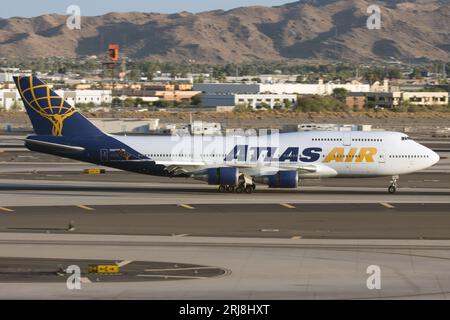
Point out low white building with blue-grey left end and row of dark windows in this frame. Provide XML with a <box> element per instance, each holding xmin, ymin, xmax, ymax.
<box><xmin>202</xmin><ymin>94</ymin><xmax>297</xmax><ymax>109</ymax></box>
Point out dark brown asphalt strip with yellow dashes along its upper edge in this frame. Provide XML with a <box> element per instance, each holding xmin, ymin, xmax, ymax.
<box><xmin>0</xmin><ymin>203</ymin><xmax>450</xmax><ymax>239</ymax></box>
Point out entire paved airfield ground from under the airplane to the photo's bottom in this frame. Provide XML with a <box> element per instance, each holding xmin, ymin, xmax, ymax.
<box><xmin>0</xmin><ymin>155</ymin><xmax>450</xmax><ymax>299</ymax></box>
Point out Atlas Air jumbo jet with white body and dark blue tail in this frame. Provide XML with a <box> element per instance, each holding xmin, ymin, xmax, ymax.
<box><xmin>14</xmin><ymin>76</ymin><xmax>440</xmax><ymax>194</ymax></box>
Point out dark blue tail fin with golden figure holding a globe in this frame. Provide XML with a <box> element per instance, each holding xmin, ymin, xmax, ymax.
<box><xmin>14</xmin><ymin>76</ymin><xmax>104</xmax><ymax>137</ymax></box>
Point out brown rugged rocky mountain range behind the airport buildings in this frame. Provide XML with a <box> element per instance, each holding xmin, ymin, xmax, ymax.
<box><xmin>0</xmin><ymin>0</ymin><xmax>450</xmax><ymax>63</ymax></box>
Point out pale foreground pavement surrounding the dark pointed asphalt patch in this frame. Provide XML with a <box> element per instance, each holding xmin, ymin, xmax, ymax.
<box><xmin>0</xmin><ymin>233</ymin><xmax>450</xmax><ymax>300</ymax></box>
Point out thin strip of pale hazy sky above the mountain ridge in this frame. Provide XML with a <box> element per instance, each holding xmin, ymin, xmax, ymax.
<box><xmin>0</xmin><ymin>0</ymin><xmax>294</xmax><ymax>18</ymax></box>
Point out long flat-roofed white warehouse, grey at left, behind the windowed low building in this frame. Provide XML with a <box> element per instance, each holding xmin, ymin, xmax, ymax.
<box><xmin>193</xmin><ymin>80</ymin><xmax>374</xmax><ymax>95</ymax></box>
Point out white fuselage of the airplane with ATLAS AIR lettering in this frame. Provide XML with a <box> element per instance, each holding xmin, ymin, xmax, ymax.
<box><xmin>114</xmin><ymin>131</ymin><xmax>439</xmax><ymax>178</ymax></box>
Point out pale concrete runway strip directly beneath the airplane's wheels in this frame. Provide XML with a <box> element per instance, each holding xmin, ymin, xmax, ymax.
<box><xmin>0</xmin><ymin>175</ymin><xmax>450</xmax><ymax>206</ymax></box>
